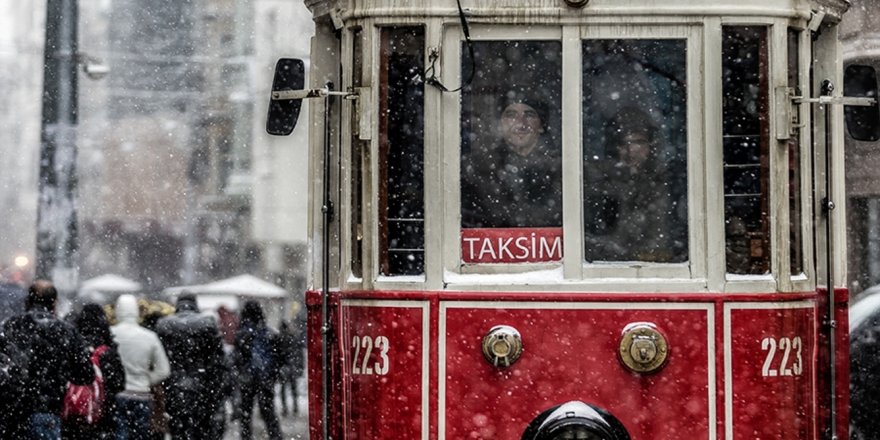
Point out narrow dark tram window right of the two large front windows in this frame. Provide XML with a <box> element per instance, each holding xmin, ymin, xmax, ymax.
<box><xmin>721</xmin><ymin>26</ymin><xmax>770</xmax><ymax>274</ymax></box>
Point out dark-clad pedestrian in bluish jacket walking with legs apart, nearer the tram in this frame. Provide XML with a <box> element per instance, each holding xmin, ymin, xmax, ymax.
<box><xmin>235</xmin><ymin>300</ymin><xmax>281</xmax><ymax>440</ymax></box>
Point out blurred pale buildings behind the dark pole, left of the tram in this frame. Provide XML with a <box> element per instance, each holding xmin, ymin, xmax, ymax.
<box><xmin>0</xmin><ymin>0</ymin><xmax>312</xmax><ymax>292</ymax></box>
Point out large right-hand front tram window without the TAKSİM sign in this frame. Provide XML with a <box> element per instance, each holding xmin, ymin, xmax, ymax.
<box><xmin>582</xmin><ymin>39</ymin><xmax>688</xmax><ymax>263</ymax></box>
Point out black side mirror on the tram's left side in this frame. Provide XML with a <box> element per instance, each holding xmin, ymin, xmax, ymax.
<box><xmin>266</xmin><ymin>58</ymin><xmax>305</xmax><ymax>136</ymax></box>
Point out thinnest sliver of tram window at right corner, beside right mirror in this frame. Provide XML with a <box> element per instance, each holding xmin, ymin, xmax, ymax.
<box><xmin>788</xmin><ymin>29</ymin><xmax>804</xmax><ymax>275</ymax></box>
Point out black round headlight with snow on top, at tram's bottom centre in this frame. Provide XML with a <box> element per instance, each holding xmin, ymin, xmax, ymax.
<box><xmin>522</xmin><ymin>400</ymin><xmax>630</xmax><ymax>440</ymax></box>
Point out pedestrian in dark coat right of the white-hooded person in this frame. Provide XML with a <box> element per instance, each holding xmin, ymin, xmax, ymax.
<box><xmin>156</xmin><ymin>293</ymin><xmax>229</xmax><ymax>440</ymax></box>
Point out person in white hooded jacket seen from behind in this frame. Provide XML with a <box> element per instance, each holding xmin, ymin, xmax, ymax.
<box><xmin>110</xmin><ymin>294</ymin><xmax>171</xmax><ymax>440</ymax></box>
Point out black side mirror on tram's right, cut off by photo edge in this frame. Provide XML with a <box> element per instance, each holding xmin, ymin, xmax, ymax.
<box><xmin>843</xmin><ymin>64</ymin><xmax>880</xmax><ymax>142</ymax></box>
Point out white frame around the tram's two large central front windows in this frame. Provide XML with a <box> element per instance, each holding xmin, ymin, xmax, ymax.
<box><xmin>441</xmin><ymin>24</ymin><xmax>707</xmax><ymax>292</ymax></box>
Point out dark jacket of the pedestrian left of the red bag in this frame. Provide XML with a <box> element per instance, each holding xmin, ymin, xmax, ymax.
<box><xmin>3</xmin><ymin>309</ymin><xmax>95</xmax><ymax>415</ymax></box>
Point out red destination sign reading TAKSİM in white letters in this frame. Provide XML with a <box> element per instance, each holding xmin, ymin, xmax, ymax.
<box><xmin>461</xmin><ymin>228</ymin><xmax>562</xmax><ymax>263</ymax></box>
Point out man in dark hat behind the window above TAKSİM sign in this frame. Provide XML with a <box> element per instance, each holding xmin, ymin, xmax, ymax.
<box><xmin>461</xmin><ymin>93</ymin><xmax>562</xmax><ymax>228</ymax></box>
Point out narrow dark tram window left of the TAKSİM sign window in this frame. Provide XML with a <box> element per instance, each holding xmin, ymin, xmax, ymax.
<box><xmin>378</xmin><ymin>26</ymin><xmax>425</xmax><ymax>275</ymax></box>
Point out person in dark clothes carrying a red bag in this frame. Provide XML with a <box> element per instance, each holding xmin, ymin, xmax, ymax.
<box><xmin>61</xmin><ymin>303</ymin><xmax>125</xmax><ymax>440</ymax></box>
